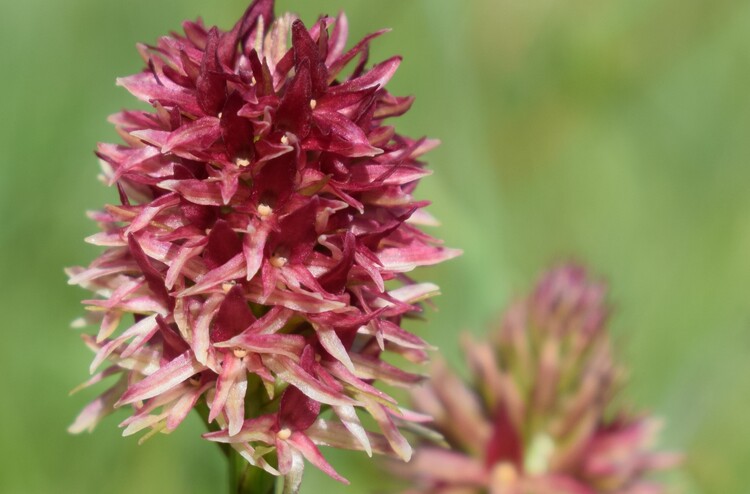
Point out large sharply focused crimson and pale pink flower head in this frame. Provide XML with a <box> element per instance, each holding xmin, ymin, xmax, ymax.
<box><xmin>68</xmin><ymin>0</ymin><xmax>459</xmax><ymax>481</ymax></box>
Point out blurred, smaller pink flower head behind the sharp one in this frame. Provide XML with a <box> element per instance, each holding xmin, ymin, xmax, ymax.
<box><xmin>397</xmin><ymin>265</ymin><xmax>678</xmax><ymax>494</ymax></box>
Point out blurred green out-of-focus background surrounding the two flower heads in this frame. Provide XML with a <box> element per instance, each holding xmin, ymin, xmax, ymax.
<box><xmin>0</xmin><ymin>0</ymin><xmax>750</xmax><ymax>494</ymax></box>
